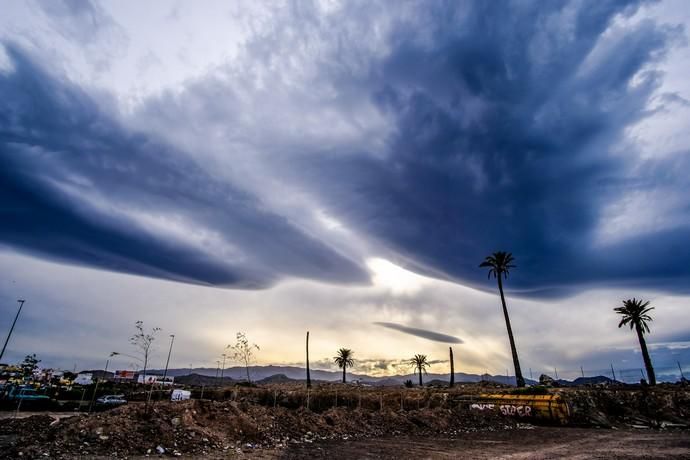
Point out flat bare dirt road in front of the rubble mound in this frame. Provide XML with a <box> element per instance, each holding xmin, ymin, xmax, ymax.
<box><xmin>278</xmin><ymin>427</ymin><xmax>690</xmax><ymax>460</ymax></box>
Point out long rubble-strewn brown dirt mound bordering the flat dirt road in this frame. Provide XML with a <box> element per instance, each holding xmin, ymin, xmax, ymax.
<box><xmin>3</xmin><ymin>401</ymin><xmax>515</xmax><ymax>458</ymax></box>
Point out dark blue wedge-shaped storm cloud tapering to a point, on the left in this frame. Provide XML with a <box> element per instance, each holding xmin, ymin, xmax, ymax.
<box><xmin>0</xmin><ymin>46</ymin><xmax>368</xmax><ymax>287</ymax></box>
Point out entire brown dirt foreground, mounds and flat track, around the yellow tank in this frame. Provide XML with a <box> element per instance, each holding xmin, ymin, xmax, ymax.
<box><xmin>0</xmin><ymin>385</ymin><xmax>690</xmax><ymax>459</ymax></box>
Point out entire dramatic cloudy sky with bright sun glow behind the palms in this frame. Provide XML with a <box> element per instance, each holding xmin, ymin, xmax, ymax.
<box><xmin>0</xmin><ymin>0</ymin><xmax>690</xmax><ymax>379</ymax></box>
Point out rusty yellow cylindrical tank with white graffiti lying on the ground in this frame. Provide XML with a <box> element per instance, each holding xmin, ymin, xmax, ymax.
<box><xmin>469</xmin><ymin>394</ymin><xmax>570</xmax><ymax>425</ymax></box>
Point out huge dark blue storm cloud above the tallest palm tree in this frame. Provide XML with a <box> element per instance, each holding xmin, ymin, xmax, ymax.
<box><xmin>282</xmin><ymin>1</ymin><xmax>690</xmax><ymax>295</ymax></box>
